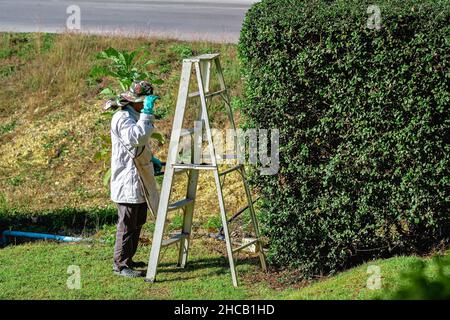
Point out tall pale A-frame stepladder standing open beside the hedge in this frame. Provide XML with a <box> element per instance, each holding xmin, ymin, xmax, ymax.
<box><xmin>146</xmin><ymin>54</ymin><xmax>266</xmax><ymax>286</ymax></box>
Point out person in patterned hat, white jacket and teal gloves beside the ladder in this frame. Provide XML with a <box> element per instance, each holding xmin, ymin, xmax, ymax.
<box><xmin>107</xmin><ymin>81</ymin><xmax>161</xmax><ymax>277</ymax></box>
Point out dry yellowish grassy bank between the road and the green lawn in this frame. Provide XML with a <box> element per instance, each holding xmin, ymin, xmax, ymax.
<box><xmin>0</xmin><ymin>34</ymin><xmax>245</xmax><ymax>225</ymax></box>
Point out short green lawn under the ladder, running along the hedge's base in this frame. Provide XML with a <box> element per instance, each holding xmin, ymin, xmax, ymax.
<box><xmin>0</xmin><ymin>238</ymin><xmax>431</xmax><ymax>299</ymax></box>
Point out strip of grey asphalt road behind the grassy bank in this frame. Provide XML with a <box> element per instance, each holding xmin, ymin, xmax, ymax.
<box><xmin>0</xmin><ymin>0</ymin><xmax>256</xmax><ymax>42</ymax></box>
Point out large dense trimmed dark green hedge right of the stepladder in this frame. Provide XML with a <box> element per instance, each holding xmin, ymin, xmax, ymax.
<box><xmin>239</xmin><ymin>0</ymin><xmax>450</xmax><ymax>276</ymax></box>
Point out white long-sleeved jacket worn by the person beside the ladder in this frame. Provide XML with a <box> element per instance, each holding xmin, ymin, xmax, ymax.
<box><xmin>111</xmin><ymin>106</ymin><xmax>154</xmax><ymax>203</ymax></box>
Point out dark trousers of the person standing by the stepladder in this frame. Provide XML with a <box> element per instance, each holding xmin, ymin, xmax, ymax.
<box><xmin>114</xmin><ymin>202</ymin><xmax>147</xmax><ymax>271</ymax></box>
